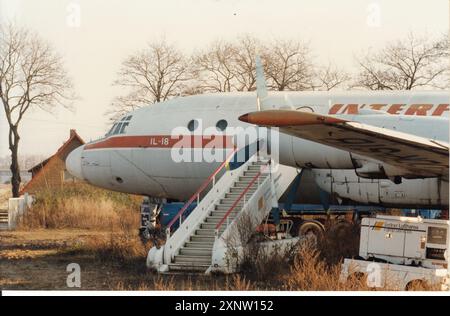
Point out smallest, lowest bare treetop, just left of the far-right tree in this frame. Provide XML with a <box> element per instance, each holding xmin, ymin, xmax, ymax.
<box><xmin>312</xmin><ymin>63</ymin><xmax>350</xmax><ymax>91</ymax></box>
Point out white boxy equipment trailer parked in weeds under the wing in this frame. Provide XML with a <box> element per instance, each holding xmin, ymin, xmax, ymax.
<box><xmin>341</xmin><ymin>215</ymin><xmax>450</xmax><ymax>290</ymax></box>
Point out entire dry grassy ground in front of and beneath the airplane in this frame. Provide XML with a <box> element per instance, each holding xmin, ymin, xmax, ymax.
<box><xmin>0</xmin><ymin>184</ymin><xmax>438</xmax><ymax>291</ymax></box>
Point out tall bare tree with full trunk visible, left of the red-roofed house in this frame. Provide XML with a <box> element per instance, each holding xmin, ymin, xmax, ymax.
<box><xmin>0</xmin><ymin>24</ymin><xmax>73</xmax><ymax>197</ymax></box>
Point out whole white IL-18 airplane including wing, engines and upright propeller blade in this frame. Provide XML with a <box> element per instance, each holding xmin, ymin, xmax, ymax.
<box><xmin>66</xmin><ymin>60</ymin><xmax>450</xmax><ymax>209</ymax></box>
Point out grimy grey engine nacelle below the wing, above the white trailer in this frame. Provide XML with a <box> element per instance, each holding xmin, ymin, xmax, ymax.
<box><xmin>312</xmin><ymin>169</ymin><xmax>449</xmax><ymax>209</ymax></box>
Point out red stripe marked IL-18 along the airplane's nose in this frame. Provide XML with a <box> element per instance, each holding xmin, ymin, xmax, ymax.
<box><xmin>84</xmin><ymin>135</ymin><xmax>233</xmax><ymax>150</ymax></box>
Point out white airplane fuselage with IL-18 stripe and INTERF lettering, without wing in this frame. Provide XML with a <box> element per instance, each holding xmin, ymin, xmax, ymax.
<box><xmin>67</xmin><ymin>91</ymin><xmax>449</xmax><ymax>205</ymax></box>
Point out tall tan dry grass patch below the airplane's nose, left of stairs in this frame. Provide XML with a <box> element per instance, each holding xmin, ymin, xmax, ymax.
<box><xmin>19</xmin><ymin>183</ymin><xmax>147</xmax><ymax>263</ymax></box>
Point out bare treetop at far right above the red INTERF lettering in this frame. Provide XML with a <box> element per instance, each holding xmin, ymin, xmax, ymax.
<box><xmin>354</xmin><ymin>33</ymin><xmax>448</xmax><ymax>90</ymax></box>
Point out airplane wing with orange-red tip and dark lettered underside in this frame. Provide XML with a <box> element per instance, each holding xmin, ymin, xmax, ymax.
<box><xmin>239</xmin><ymin>110</ymin><xmax>449</xmax><ymax>179</ymax></box>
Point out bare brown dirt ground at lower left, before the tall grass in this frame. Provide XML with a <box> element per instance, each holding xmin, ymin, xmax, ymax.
<box><xmin>0</xmin><ymin>230</ymin><xmax>151</xmax><ymax>290</ymax></box>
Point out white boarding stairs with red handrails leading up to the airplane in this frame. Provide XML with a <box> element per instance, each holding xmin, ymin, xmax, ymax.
<box><xmin>147</xmin><ymin>149</ymin><xmax>297</xmax><ymax>273</ymax></box>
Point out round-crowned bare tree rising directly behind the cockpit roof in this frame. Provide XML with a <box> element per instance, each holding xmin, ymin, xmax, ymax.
<box><xmin>109</xmin><ymin>40</ymin><xmax>190</xmax><ymax>116</ymax></box>
